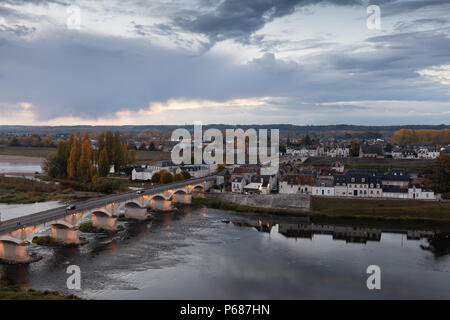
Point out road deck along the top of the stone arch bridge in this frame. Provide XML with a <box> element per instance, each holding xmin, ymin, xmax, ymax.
<box><xmin>0</xmin><ymin>175</ymin><xmax>216</xmax><ymax>234</ymax></box>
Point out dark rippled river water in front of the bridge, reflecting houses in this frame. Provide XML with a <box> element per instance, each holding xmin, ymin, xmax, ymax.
<box><xmin>0</xmin><ymin>208</ymin><xmax>450</xmax><ymax>299</ymax></box>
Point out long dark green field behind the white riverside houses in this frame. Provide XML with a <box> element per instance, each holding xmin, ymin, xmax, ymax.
<box><xmin>305</xmin><ymin>158</ymin><xmax>434</xmax><ymax>174</ymax></box>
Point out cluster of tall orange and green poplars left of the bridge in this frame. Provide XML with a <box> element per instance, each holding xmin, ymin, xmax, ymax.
<box><xmin>44</xmin><ymin>131</ymin><xmax>136</xmax><ymax>182</ymax></box>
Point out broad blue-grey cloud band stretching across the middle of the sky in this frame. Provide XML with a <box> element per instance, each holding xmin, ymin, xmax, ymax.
<box><xmin>0</xmin><ymin>22</ymin><xmax>450</xmax><ymax>119</ymax></box>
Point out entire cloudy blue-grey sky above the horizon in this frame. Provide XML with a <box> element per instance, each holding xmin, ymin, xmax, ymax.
<box><xmin>0</xmin><ymin>0</ymin><xmax>450</xmax><ymax>125</ymax></box>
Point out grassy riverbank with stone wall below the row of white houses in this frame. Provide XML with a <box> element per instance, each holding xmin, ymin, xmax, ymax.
<box><xmin>192</xmin><ymin>196</ymin><xmax>450</xmax><ymax>226</ymax></box>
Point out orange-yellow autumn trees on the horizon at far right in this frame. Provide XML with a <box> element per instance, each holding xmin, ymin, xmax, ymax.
<box><xmin>392</xmin><ymin>129</ymin><xmax>450</xmax><ymax>145</ymax></box>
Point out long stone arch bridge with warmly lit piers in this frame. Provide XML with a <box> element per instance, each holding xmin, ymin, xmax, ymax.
<box><xmin>0</xmin><ymin>176</ymin><xmax>215</xmax><ymax>263</ymax></box>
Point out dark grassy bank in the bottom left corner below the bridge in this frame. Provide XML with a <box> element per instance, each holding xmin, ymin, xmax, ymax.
<box><xmin>0</xmin><ymin>285</ymin><xmax>82</xmax><ymax>300</ymax></box>
